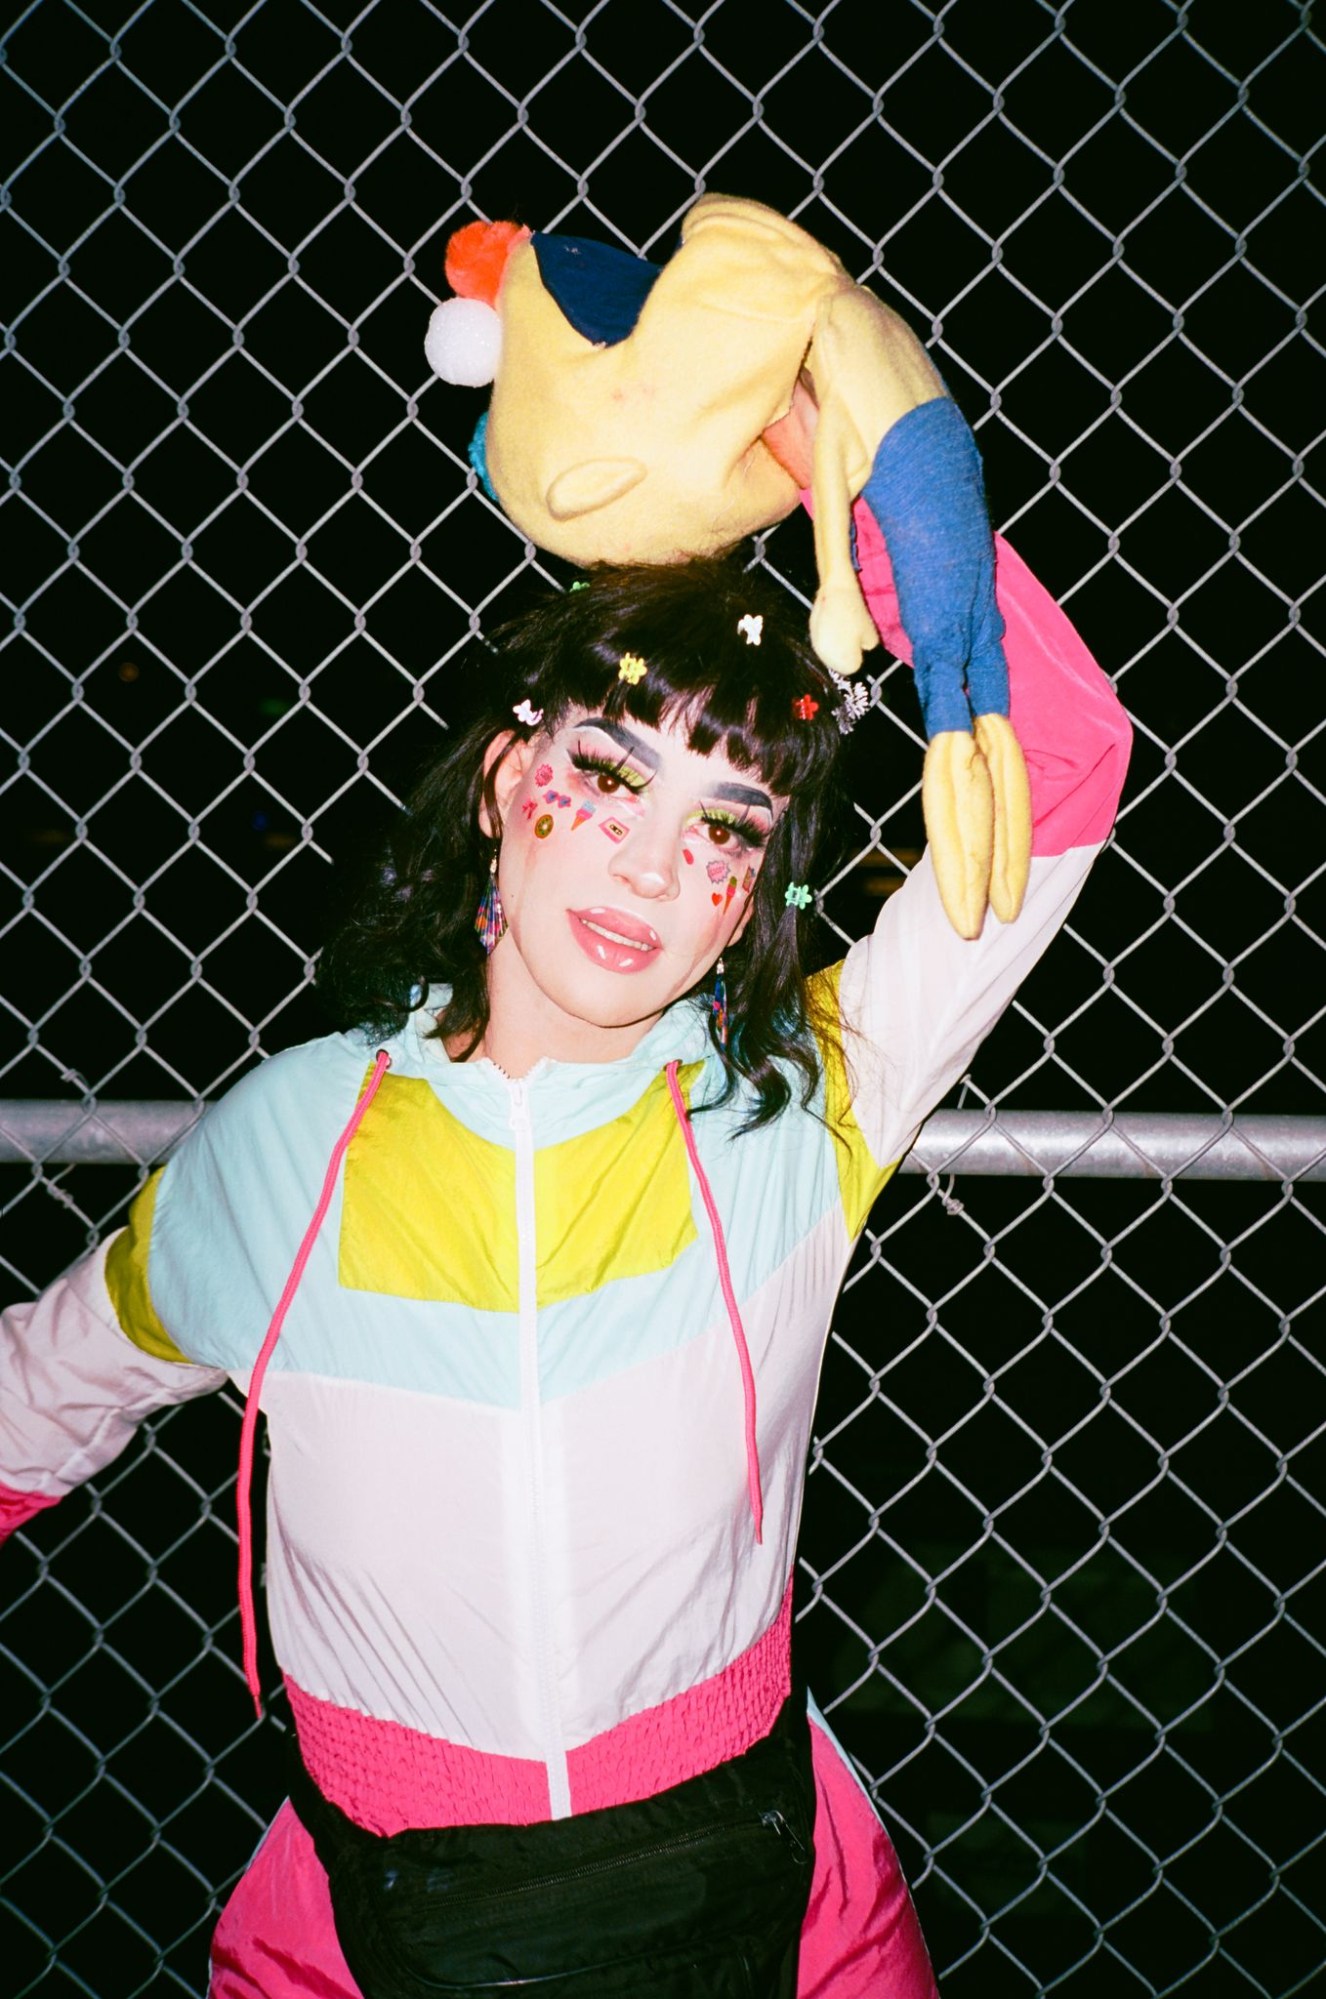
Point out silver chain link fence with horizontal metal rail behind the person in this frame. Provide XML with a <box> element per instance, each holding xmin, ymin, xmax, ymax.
<box><xmin>0</xmin><ymin>0</ymin><xmax>1326</xmax><ymax>1999</ymax></box>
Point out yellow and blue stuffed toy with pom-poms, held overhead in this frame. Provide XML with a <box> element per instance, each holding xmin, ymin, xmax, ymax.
<box><xmin>426</xmin><ymin>194</ymin><xmax>1030</xmax><ymax>938</ymax></box>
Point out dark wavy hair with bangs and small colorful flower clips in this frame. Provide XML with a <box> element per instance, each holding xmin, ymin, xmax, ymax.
<box><xmin>318</xmin><ymin>558</ymin><xmax>842</xmax><ymax>1125</ymax></box>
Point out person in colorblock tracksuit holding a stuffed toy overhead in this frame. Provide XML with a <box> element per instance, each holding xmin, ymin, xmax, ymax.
<box><xmin>0</xmin><ymin>558</ymin><xmax>1128</xmax><ymax>1999</ymax></box>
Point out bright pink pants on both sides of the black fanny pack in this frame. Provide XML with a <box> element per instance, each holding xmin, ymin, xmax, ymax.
<box><xmin>210</xmin><ymin>1719</ymin><xmax>938</xmax><ymax>1999</ymax></box>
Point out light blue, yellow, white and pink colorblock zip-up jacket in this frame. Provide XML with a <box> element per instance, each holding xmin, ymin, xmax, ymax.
<box><xmin>0</xmin><ymin>527</ymin><xmax>1128</xmax><ymax>1831</ymax></box>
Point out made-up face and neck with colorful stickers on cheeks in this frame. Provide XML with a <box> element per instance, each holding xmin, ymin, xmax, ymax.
<box><xmin>490</xmin><ymin>712</ymin><xmax>786</xmax><ymax>1059</ymax></box>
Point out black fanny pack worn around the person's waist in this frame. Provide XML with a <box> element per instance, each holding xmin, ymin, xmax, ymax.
<box><xmin>290</xmin><ymin>1693</ymin><xmax>814</xmax><ymax>1999</ymax></box>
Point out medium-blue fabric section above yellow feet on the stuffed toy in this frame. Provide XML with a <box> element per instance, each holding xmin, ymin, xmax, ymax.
<box><xmin>862</xmin><ymin>396</ymin><xmax>1008</xmax><ymax>736</ymax></box>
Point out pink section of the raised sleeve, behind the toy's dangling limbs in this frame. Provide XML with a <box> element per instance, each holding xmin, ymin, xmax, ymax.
<box><xmin>852</xmin><ymin>500</ymin><xmax>1132</xmax><ymax>854</ymax></box>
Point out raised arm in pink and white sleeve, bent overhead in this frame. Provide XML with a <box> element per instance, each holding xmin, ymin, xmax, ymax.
<box><xmin>840</xmin><ymin>504</ymin><xmax>1132</xmax><ymax>1179</ymax></box>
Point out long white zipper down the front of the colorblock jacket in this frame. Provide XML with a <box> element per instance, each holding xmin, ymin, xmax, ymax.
<box><xmin>506</xmin><ymin>1081</ymin><xmax>570</xmax><ymax>1819</ymax></box>
